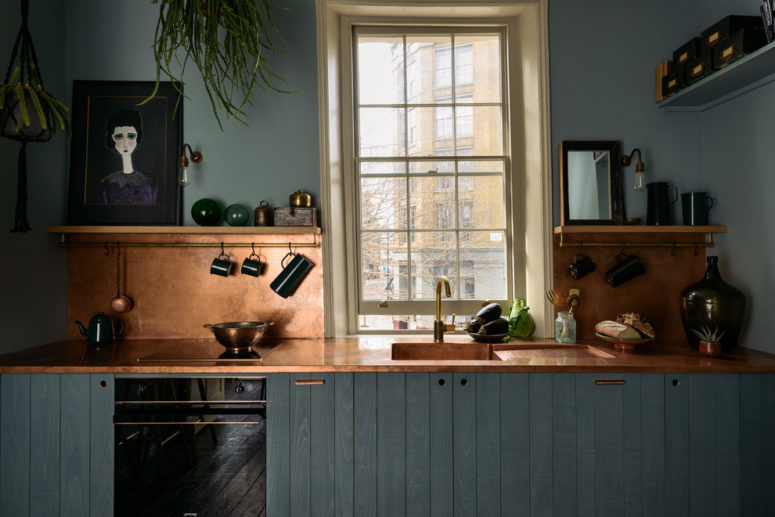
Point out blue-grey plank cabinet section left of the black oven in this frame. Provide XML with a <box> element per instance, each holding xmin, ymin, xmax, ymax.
<box><xmin>0</xmin><ymin>374</ymin><xmax>113</xmax><ymax>517</ymax></box>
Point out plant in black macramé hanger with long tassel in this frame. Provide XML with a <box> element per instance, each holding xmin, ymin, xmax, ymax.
<box><xmin>0</xmin><ymin>0</ymin><xmax>70</xmax><ymax>232</ymax></box>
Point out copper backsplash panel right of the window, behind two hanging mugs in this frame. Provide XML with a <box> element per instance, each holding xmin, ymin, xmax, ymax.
<box><xmin>554</xmin><ymin>233</ymin><xmax>705</xmax><ymax>339</ymax></box>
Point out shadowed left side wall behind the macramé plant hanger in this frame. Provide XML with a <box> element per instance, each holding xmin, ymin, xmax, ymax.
<box><xmin>0</xmin><ymin>0</ymin><xmax>68</xmax><ymax>353</ymax></box>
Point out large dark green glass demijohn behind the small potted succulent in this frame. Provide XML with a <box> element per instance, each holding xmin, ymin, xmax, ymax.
<box><xmin>681</xmin><ymin>257</ymin><xmax>745</xmax><ymax>353</ymax></box>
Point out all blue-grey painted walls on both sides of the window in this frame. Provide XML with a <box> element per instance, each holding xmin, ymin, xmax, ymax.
<box><xmin>0</xmin><ymin>0</ymin><xmax>775</xmax><ymax>352</ymax></box>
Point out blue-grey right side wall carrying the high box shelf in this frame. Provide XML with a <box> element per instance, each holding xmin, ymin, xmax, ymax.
<box><xmin>691</xmin><ymin>0</ymin><xmax>775</xmax><ymax>353</ymax></box>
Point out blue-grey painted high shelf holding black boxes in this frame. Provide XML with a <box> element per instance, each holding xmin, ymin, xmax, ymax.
<box><xmin>657</xmin><ymin>42</ymin><xmax>775</xmax><ymax>111</ymax></box>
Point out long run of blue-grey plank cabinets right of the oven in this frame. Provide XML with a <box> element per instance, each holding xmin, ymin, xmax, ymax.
<box><xmin>267</xmin><ymin>372</ymin><xmax>775</xmax><ymax>516</ymax></box>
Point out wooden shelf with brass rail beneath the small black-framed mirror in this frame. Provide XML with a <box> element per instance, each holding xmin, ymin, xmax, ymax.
<box><xmin>554</xmin><ymin>225</ymin><xmax>727</xmax><ymax>249</ymax></box>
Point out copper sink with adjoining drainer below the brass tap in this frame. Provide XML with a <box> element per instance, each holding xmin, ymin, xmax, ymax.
<box><xmin>390</xmin><ymin>340</ymin><xmax>613</xmax><ymax>361</ymax></box>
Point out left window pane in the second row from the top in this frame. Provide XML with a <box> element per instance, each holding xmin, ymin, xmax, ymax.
<box><xmin>358</xmin><ymin>108</ymin><xmax>404</xmax><ymax>158</ymax></box>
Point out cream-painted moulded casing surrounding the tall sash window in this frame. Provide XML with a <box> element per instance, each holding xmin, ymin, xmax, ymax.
<box><xmin>316</xmin><ymin>0</ymin><xmax>552</xmax><ymax>336</ymax></box>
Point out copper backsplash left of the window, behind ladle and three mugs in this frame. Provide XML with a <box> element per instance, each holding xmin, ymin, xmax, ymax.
<box><xmin>68</xmin><ymin>234</ymin><xmax>324</xmax><ymax>339</ymax></box>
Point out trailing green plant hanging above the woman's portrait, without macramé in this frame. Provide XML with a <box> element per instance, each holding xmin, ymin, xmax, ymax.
<box><xmin>141</xmin><ymin>0</ymin><xmax>288</xmax><ymax>129</ymax></box>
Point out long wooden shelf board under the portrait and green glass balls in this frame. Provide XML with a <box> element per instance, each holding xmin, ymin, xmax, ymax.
<box><xmin>48</xmin><ymin>226</ymin><xmax>321</xmax><ymax>235</ymax></box>
